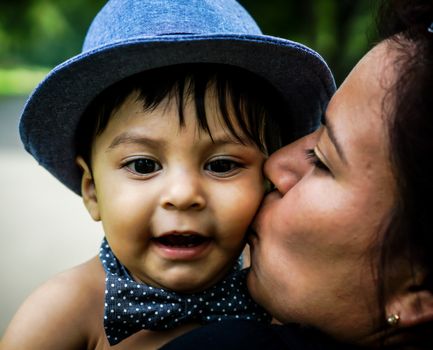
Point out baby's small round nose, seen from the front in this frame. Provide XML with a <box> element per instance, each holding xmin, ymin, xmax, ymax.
<box><xmin>161</xmin><ymin>172</ymin><xmax>206</xmax><ymax>210</ymax></box>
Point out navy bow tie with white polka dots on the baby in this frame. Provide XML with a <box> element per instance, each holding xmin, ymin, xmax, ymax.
<box><xmin>99</xmin><ymin>239</ymin><xmax>271</xmax><ymax>345</ymax></box>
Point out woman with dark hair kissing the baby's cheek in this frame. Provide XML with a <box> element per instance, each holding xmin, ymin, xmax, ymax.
<box><xmin>161</xmin><ymin>0</ymin><xmax>433</xmax><ymax>349</ymax></box>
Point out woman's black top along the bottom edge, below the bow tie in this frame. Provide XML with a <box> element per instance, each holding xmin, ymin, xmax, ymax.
<box><xmin>161</xmin><ymin>320</ymin><xmax>355</xmax><ymax>350</ymax></box>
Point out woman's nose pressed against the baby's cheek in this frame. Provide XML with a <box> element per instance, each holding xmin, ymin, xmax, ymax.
<box><xmin>264</xmin><ymin>131</ymin><xmax>318</xmax><ymax>194</ymax></box>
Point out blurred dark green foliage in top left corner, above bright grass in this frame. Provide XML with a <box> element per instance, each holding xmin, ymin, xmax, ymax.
<box><xmin>0</xmin><ymin>0</ymin><xmax>105</xmax><ymax>67</ymax></box>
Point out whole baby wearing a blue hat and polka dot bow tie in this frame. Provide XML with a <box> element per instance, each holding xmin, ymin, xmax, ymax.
<box><xmin>2</xmin><ymin>0</ymin><xmax>327</xmax><ymax>349</ymax></box>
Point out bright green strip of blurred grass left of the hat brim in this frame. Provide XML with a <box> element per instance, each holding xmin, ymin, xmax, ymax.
<box><xmin>0</xmin><ymin>67</ymin><xmax>50</xmax><ymax>96</ymax></box>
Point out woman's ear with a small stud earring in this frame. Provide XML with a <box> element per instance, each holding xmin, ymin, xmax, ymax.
<box><xmin>386</xmin><ymin>273</ymin><xmax>433</xmax><ymax>327</ymax></box>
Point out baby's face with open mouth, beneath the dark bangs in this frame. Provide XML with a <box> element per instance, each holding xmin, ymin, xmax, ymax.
<box><xmin>79</xmin><ymin>90</ymin><xmax>265</xmax><ymax>292</ymax></box>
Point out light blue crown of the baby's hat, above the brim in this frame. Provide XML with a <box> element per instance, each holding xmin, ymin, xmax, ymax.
<box><xmin>83</xmin><ymin>0</ymin><xmax>261</xmax><ymax>52</ymax></box>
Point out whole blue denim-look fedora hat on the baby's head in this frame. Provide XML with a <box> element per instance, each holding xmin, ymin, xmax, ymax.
<box><xmin>20</xmin><ymin>0</ymin><xmax>335</xmax><ymax>194</ymax></box>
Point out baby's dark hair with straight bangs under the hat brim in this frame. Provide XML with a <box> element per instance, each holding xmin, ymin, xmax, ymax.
<box><xmin>76</xmin><ymin>63</ymin><xmax>289</xmax><ymax>165</ymax></box>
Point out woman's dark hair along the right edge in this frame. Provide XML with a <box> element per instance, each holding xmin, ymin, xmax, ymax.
<box><xmin>372</xmin><ymin>0</ymin><xmax>433</xmax><ymax>349</ymax></box>
